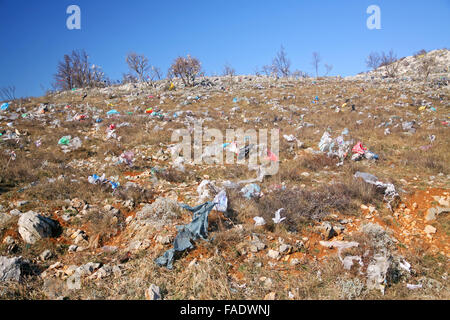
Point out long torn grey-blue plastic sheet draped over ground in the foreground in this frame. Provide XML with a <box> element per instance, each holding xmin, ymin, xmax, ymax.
<box><xmin>155</xmin><ymin>201</ymin><xmax>217</xmax><ymax>269</ymax></box>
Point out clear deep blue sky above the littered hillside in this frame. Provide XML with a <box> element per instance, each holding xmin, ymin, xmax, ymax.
<box><xmin>0</xmin><ymin>0</ymin><xmax>450</xmax><ymax>96</ymax></box>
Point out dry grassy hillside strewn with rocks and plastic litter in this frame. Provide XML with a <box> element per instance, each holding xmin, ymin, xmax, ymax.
<box><xmin>0</xmin><ymin>75</ymin><xmax>450</xmax><ymax>300</ymax></box>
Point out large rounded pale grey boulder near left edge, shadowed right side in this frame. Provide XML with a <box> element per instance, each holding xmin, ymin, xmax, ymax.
<box><xmin>18</xmin><ymin>211</ymin><xmax>58</xmax><ymax>244</ymax></box>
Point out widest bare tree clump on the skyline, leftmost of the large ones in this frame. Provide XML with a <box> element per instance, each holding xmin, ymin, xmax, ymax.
<box><xmin>54</xmin><ymin>50</ymin><xmax>108</xmax><ymax>90</ymax></box>
